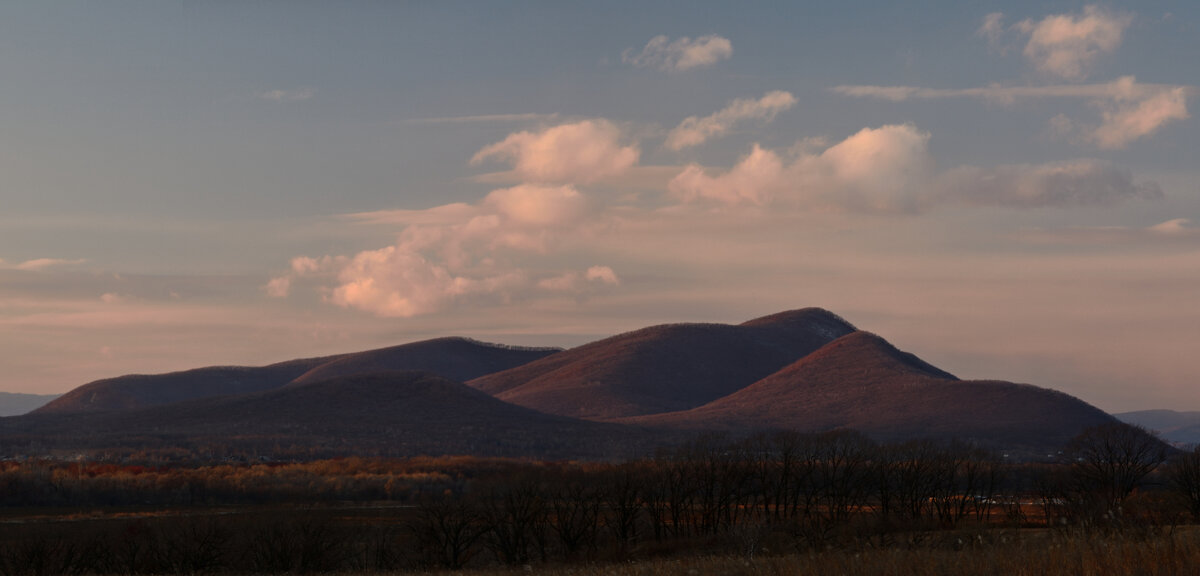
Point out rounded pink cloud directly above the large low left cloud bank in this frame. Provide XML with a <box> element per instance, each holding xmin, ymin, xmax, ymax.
<box><xmin>470</xmin><ymin>120</ymin><xmax>641</xmax><ymax>184</ymax></box>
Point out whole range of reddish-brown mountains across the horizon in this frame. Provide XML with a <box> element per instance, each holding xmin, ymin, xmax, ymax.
<box><xmin>0</xmin><ymin>308</ymin><xmax>1114</xmax><ymax>458</ymax></box>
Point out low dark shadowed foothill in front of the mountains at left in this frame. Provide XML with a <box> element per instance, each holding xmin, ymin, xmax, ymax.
<box><xmin>0</xmin><ymin>371</ymin><xmax>644</xmax><ymax>457</ymax></box>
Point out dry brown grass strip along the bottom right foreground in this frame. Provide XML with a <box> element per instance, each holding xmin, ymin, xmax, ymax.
<box><xmin>417</xmin><ymin>529</ymin><xmax>1200</xmax><ymax>576</ymax></box>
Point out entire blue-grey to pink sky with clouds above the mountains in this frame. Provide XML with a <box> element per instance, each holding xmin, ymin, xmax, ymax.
<box><xmin>0</xmin><ymin>1</ymin><xmax>1200</xmax><ymax>412</ymax></box>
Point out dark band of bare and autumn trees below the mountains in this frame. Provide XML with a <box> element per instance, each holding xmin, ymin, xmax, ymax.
<box><xmin>0</xmin><ymin>424</ymin><xmax>1200</xmax><ymax>574</ymax></box>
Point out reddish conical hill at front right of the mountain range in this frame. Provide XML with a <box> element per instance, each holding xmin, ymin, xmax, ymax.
<box><xmin>620</xmin><ymin>332</ymin><xmax>1112</xmax><ymax>449</ymax></box>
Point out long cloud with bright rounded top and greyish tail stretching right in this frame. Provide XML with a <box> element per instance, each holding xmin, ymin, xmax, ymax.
<box><xmin>670</xmin><ymin>125</ymin><xmax>1162</xmax><ymax>214</ymax></box>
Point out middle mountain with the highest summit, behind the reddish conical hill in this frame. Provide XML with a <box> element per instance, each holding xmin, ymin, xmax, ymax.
<box><xmin>468</xmin><ymin>308</ymin><xmax>856</xmax><ymax>420</ymax></box>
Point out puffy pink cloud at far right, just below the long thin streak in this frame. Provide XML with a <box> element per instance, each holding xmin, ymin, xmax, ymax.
<box><xmin>1088</xmin><ymin>88</ymin><xmax>1189</xmax><ymax>150</ymax></box>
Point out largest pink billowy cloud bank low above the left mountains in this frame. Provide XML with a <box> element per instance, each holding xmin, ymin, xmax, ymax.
<box><xmin>272</xmin><ymin>184</ymin><xmax>619</xmax><ymax>318</ymax></box>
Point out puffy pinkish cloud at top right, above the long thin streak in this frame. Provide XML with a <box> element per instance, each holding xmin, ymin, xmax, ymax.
<box><xmin>1015</xmin><ymin>5</ymin><xmax>1133</xmax><ymax>80</ymax></box>
